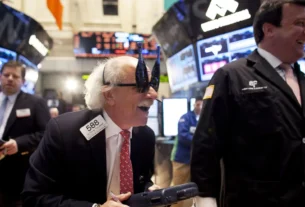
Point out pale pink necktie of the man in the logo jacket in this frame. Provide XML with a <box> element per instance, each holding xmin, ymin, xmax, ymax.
<box><xmin>280</xmin><ymin>64</ymin><xmax>301</xmax><ymax>104</ymax></box>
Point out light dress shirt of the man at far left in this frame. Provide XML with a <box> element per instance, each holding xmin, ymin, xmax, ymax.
<box><xmin>0</xmin><ymin>91</ymin><xmax>20</xmax><ymax>139</ymax></box>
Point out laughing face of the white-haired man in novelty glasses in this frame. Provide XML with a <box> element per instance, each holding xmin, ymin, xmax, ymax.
<box><xmin>104</xmin><ymin>58</ymin><xmax>157</xmax><ymax>129</ymax></box>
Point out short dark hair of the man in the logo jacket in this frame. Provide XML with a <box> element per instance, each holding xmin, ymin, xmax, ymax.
<box><xmin>253</xmin><ymin>0</ymin><xmax>305</xmax><ymax>44</ymax></box>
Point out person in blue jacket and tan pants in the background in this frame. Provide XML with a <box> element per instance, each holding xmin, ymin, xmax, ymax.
<box><xmin>171</xmin><ymin>97</ymin><xmax>203</xmax><ymax>207</ymax></box>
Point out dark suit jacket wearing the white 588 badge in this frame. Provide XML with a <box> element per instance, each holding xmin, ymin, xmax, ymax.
<box><xmin>22</xmin><ymin>110</ymin><xmax>155</xmax><ymax>207</ymax></box>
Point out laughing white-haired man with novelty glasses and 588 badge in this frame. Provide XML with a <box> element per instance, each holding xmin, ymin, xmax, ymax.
<box><xmin>22</xmin><ymin>56</ymin><xmax>159</xmax><ymax>207</ymax></box>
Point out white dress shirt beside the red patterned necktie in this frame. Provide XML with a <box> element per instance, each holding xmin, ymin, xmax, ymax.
<box><xmin>103</xmin><ymin>111</ymin><xmax>132</xmax><ymax>197</ymax></box>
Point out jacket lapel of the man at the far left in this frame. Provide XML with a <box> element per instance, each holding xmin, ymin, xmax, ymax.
<box><xmin>2</xmin><ymin>91</ymin><xmax>26</xmax><ymax>140</ymax></box>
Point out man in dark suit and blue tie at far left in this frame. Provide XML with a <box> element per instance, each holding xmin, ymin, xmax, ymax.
<box><xmin>0</xmin><ymin>61</ymin><xmax>50</xmax><ymax>207</ymax></box>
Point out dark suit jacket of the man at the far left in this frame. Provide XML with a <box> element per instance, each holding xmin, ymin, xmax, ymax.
<box><xmin>0</xmin><ymin>91</ymin><xmax>50</xmax><ymax>196</ymax></box>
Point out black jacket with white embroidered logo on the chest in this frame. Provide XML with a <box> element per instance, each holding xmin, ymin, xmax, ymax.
<box><xmin>191</xmin><ymin>51</ymin><xmax>305</xmax><ymax>207</ymax></box>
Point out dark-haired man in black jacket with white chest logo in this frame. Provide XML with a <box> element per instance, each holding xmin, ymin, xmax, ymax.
<box><xmin>191</xmin><ymin>0</ymin><xmax>305</xmax><ymax>207</ymax></box>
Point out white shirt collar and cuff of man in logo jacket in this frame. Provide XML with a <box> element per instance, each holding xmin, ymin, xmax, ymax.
<box><xmin>195</xmin><ymin>47</ymin><xmax>285</xmax><ymax>207</ymax></box>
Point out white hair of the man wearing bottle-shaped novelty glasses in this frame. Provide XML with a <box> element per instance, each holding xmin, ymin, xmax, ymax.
<box><xmin>85</xmin><ymin>56</ymin><xmax>138</xmax><ymax>110</ymax></box>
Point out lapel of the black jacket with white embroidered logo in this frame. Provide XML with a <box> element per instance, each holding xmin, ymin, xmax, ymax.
<box><xmin>247</xmin><ymin>50</ymin><xmax>300</xmax><ymax>108</ymax></box>
